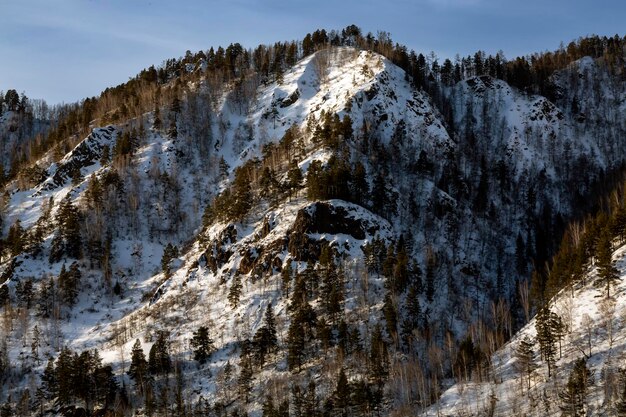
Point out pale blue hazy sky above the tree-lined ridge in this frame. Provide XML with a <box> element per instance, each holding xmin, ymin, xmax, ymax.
<box><xmin>0</xmin><ymin>0</ymin><xmax>626</xmax><ymax>103</ymax></box>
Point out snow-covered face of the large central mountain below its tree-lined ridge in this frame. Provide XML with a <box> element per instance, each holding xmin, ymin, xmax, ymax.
<box><xmin>0</xmin><ymin>47</ymin><xmax>626</xmax><ymax>416</ymax></box>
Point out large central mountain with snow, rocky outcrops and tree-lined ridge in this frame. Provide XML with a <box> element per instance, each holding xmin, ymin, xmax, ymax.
<box><xmin>0</xmin><ymin>27</ymin><xmax>626</xmax><ymax>416</ymax></box>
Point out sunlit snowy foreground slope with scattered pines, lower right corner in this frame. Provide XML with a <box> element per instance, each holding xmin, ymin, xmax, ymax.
<box><xmin>423</xmin><ymin>242</ymin><xmax>626</xmax><ymax>417</ymax></box>
